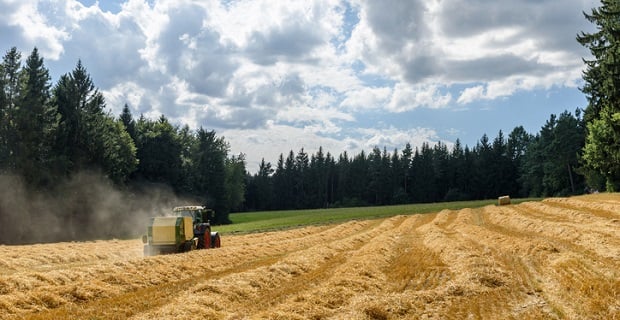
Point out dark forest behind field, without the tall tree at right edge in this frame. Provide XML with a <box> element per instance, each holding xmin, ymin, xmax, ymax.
<box><xmin>0</xmin><ymin>48</ymin><xmax>585</xmax><ymax>214</ymax></box>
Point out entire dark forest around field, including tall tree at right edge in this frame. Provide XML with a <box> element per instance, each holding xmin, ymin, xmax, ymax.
<box><xmin>0</xmin><ymin>1</ymin><xmax>620</xmax><ymax>243</ymax></box>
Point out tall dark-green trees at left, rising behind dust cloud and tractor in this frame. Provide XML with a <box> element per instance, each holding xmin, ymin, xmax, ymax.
<box><xmin>0</xmin><ymin>48</ymin><xmax>246</xmax><ymax>240</ymax></box>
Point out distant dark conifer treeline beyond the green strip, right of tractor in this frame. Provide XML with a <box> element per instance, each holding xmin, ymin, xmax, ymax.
<box><xmin>245</xmin><ymin>110</ymin><xmax>585</xmax><ymax>210</ymax></box>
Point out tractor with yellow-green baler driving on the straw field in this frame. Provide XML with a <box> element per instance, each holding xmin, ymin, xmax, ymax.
<box><xmin>142</xmin><ymin>206</ymin><xmax>221</xmax><ymax>256</ymax></box>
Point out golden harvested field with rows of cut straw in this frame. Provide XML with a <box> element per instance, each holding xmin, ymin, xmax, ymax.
<box><xmin>0</xmin><ymin>194</ymin><xmax>620</xmax><ymax>319</ymax></box>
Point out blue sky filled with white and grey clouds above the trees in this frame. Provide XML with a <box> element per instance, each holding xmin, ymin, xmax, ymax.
<box><xmin>0</xmin><ymin>0</ymin><xmax>600</xmax><ymax>172</ymax></box>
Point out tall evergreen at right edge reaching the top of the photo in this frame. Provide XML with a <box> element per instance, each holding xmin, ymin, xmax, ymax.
<box><xmin>577</xmin><ymin>0</ymin><xmax>620</xmax><ymax>191</ymax></box>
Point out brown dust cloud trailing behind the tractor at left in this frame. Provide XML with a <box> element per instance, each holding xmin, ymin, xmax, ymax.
<box><xmin>0</xmin><ymin>172</ymin><xmax>193</xmax><ymax>244</ymax></box>
